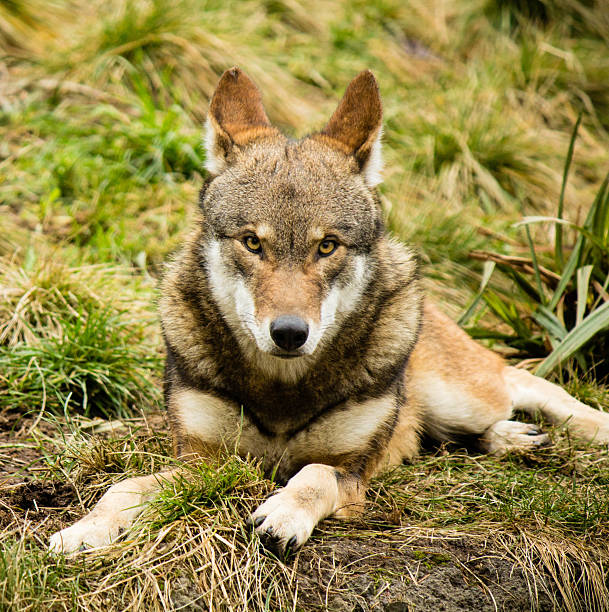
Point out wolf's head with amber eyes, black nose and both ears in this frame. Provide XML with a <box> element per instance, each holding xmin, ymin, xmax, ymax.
<box><xmin>200</xmin><ymin>68</ymin><xmax>383</xmax><ymax>379</ymax></box>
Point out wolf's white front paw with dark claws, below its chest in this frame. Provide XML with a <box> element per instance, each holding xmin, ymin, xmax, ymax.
<box><xmin>248</xmin><ymin>489</ymin><xmax>317</xmax><ymax>557</ymax></box>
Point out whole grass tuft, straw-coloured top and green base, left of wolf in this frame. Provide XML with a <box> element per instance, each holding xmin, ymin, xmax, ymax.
<box><xmin>0</xmin><ymin>246</ymin><xmax>161</xmax><ymax>416</ymax></box>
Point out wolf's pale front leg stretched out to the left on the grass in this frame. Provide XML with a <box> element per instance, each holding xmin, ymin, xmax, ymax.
<box><xmin>49</xmin><ymin>469</ymin><xmax>179</xmax><ymax>553</ymax></box>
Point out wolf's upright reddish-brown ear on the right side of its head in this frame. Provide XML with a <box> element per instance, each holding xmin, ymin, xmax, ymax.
<box><xmin>321</xmin><ymin>70</ymin><xmax>383</xmax><ymax>187</ymax></box>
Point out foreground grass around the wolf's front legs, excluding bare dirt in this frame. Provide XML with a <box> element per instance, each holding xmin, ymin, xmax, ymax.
<box><xmin>0</xmin><ymin>427</ymin><xmax>609</xmax><ymax>610</ymax></box>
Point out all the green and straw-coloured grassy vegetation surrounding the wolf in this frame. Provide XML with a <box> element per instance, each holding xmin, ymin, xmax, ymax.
<box><xmin>0</xmin><ymin>0</ymin><xmax>609</xmax><ymax>611</ymax></box>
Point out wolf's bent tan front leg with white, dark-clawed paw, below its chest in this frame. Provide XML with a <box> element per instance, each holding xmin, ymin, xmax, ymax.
<box><xmin>249</xmin><ymin>463</ymin><xmax>365</xmax><ymax>556</ymax></box>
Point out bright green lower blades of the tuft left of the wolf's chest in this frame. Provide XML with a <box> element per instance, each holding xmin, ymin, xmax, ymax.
<box><xmin>0</xmin><ymin>309</ymin><xmax>161</xmax><ymax>417</ymax></box>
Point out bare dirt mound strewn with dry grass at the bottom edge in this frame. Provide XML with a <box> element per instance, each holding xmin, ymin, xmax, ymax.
<box><xmin>297</xmin><ymin>537</ymin><xmax>554</xmax><ymax>612</ymax></box>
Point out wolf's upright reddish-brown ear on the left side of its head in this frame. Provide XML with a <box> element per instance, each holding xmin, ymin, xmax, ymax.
<box><xmin>205</xmin><ymin>67</ymin><xmax>278</xmax><ymax>174</ymax></box>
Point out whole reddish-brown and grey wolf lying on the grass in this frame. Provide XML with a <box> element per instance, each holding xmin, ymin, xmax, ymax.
<box><xmin>51</xmin><ymin>68</ymin><xmax>609</xmax><ymax>554</ymax></box>
